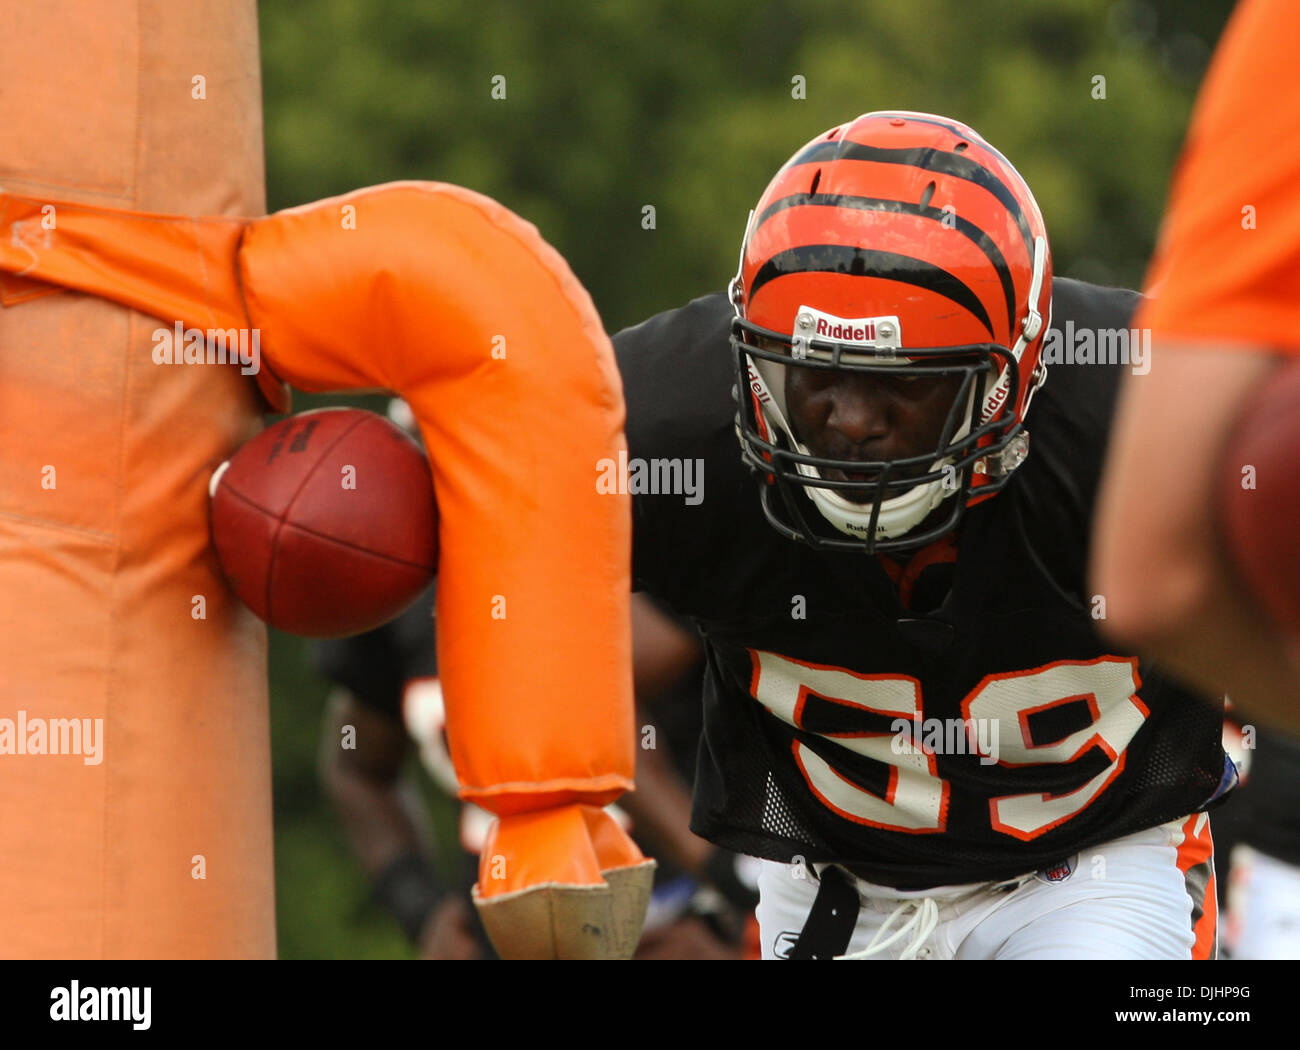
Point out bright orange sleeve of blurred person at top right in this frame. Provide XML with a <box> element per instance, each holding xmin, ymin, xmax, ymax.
<box><xmin>1138</xmin><ymin>0</ymin><xmax>1300</xmax><ymax>353</ymax></box>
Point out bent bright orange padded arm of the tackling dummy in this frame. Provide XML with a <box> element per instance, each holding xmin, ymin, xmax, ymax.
<box><xmin>0</xmin><ymin>182</ymin><xmax>640</xmax><ymax>891</ymax></box>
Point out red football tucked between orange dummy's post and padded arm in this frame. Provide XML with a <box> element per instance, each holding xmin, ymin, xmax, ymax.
<box><xmin>209</xmin><ymin>408</ymin><xmax>438</xmax><ymax>638</ymax></box>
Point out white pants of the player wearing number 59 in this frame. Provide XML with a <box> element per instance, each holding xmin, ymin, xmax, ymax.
<box><xmin>758</xmin><ymin>813</ymin><xmax>1217</xmax><ymax>959</ymax></box>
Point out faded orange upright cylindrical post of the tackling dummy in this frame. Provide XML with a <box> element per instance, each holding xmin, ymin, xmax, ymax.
<box><xmin>0</xmin><ymin>0</ymin><xmax>276</xmax><ymax>958</ymax></box>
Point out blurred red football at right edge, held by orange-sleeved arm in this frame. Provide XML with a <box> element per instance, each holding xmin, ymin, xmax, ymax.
<box><xmin>1218</xmin><ymin>363</ymin><xmax>1300</xmax><ymax>638</ymax></box>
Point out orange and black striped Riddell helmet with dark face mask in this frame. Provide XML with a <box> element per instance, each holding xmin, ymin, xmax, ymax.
<box><xmin>731</xmin><ymin>112</ymin><xmax>1052</xmax><ymax>551</ymax></box>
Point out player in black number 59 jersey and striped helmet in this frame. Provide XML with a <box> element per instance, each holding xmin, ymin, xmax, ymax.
<box><xmin>615</xmin><ymin>112</ymin><xmax>1232</xmax><ymax>959</ymax></box>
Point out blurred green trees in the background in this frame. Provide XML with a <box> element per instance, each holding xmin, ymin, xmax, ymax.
<box><xmin>261</xmin><ymin>0</ymin><xmax>1231</xmax><ymax>958</ymax></box>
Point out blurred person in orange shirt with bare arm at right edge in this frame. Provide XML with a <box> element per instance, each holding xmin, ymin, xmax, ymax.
<box><xmin>1092</xmin><ymin>0</ymin><xmax>1300</xmax><ymax>729</ymax></box>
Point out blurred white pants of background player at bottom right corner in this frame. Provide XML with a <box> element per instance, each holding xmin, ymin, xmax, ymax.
<box><xmin>1227</xmin><ymin>846</ymin><xmax>1300</xmax><ymax>959</ymax></box>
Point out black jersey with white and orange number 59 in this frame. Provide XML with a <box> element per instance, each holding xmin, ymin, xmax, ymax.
<box><xmin>615</xmin><ymin>278</ymin><xmax>1225</xmax><ymax>889</ymax></box>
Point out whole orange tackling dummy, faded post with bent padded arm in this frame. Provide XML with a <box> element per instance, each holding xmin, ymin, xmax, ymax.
<box><xmin>0</xmin><ymin>0</ymin><xmax>650</xmax><ymax>958</ymax></box>
